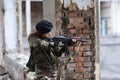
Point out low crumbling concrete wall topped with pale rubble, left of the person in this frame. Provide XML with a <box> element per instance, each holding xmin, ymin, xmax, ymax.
<box><xmin>4</xmin><ymin>53</ymin><xmax>29</xmax><ymax>80</ymax></box>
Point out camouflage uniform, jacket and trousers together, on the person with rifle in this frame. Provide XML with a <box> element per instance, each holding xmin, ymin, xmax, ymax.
<box><xmin>27</xmin><ymin>34</ymin><xmax>64</xmax><ymax>80</ymax></box>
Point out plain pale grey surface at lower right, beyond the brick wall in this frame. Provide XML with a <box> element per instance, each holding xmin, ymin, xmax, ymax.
<box><xmin>100</xmin><ymin>45</ymin><xmax>120</xmax><ymax>80</ymax></box>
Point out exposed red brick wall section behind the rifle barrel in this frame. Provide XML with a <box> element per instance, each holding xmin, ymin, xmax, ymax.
<box><xmin>56</xmin><ymin>0</ymin><xmax>95</xmax><ymax>80</ymax></box>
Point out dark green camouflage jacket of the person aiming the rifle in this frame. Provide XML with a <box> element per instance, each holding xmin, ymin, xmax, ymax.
<box><xmin>27</xmin><ymin>34</ymin><xmax>65</xmax><ymax>71</ymax></box>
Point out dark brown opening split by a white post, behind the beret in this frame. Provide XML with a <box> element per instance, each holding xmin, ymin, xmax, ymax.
<box><xmin>22</xmin><ymin>1</ymin><xmax>43</xmax><ymax>37</ymax></box>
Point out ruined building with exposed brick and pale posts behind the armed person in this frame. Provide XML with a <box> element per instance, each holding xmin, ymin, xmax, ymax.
<box><xmin>0</xmin><ymin>0</ymin><xmax>99</xmax><ymax>80</ymax></box>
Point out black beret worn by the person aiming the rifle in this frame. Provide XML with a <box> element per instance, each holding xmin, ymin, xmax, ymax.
<box><xmin>36</xmin><ymin>20</ymin><xmax>53</xmax><ymax>34</ymax></box>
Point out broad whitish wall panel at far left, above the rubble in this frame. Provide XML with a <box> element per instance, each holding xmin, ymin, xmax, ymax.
<box><xmin>4</xmin><ymin>0</ymin><xmax>17</xmax><ymax>51</ymax></box>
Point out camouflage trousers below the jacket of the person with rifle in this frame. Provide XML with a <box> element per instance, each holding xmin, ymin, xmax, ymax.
<box><xmin>34</xmin><ymin>64</ymin><xmax>57</xmax><ymax>80</ymax></box>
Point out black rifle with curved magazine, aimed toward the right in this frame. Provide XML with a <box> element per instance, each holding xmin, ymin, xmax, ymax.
<box><xmin>52</xmin><ymin>36</ymin><xmax>87</xmax><ymax>55</ymax></box>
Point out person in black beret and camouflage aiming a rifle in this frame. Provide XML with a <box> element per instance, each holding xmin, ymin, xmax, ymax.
<box><xmin>27</xmin><ymin>20</ymin><xmax>65</xmax><ymax>80</ymax></box>
